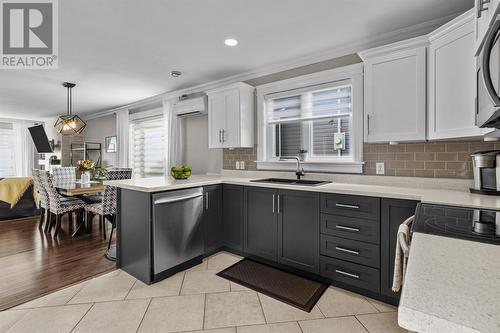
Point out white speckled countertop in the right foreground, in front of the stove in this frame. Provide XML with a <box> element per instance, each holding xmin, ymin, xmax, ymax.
<box><xmin>398</xmin><ymin>232</ymin><xmax>500</xmax><ymax>333</ymax></box>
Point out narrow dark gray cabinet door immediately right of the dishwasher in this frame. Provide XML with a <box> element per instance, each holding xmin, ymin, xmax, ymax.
<box><xmin>203</xmin><ymin>185</ymin><xmax>224</xmax><ymax>253</ymax></box>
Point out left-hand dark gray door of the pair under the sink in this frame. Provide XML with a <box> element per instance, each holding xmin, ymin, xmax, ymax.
<box><xmin>243</xmin><ymin>187</ymin><xmax>278</xmax><ymax>261</ymax></box>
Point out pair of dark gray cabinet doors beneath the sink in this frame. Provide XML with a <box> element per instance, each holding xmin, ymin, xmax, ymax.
<box><xmin>244</xmin><ymin>186</ymin><xmax>320</xmax><ymax>274</ymax></box>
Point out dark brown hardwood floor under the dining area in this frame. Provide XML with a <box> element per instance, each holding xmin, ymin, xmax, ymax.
<box><xmin>0</xmin><ymin>217</ymin><xmax>115</xmax><ymax>311</ymax></box>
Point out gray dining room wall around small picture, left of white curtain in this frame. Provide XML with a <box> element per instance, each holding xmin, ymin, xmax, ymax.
<box><xmin>84</xmin><ymin>114</ymin><xmax>118</xmax><ymax>167</ymax></box>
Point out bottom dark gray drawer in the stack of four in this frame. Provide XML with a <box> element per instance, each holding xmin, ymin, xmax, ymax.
<box><xmin>320</xmin><ymin>256</ymin><xmax>380</xmax><ymax>293</ymax></box>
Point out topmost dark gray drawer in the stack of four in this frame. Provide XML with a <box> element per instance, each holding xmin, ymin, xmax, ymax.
<box><xmin>321</xmin><ymin>194</ymin><xmax>380</xmax><ymax>220</ymax></box>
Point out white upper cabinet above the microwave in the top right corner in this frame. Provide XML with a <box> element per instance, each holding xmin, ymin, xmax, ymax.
<box><xmin>473</xmin><ymin>0</ymin><xmax>500</xmax><ymax>54</ymax></box>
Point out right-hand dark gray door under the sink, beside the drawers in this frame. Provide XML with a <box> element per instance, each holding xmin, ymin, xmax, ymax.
<box><xmin>276</xmin><ymin>191</ymin><xmax>319</xmax><ymax>274</ymax></box>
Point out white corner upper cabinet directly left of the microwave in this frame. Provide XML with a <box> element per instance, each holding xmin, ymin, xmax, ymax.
<box><xmin>427</xmin><ymin>10</ymin><xmax>489</xmax><ymax>140</ymax></box>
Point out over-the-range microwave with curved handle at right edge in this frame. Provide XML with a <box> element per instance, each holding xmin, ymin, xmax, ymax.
<box><xmin>476</xmin><ymin>11</ymin><xmax>500</xmax><ymax>128</ymax></box>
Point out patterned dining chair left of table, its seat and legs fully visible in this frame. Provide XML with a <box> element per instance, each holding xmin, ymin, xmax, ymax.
<box><xmin>40</xmin><ymin>172</ymin><xmax>85</xmax><ymax>236</ymax></box>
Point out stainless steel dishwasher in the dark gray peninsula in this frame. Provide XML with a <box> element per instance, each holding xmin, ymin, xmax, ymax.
<box><xmin>153</xmin><ymin>187</ymin><xmax>204</xmax><ymax>274</ymax></box>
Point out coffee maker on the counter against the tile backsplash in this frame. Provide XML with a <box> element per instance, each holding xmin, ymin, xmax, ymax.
<box><xmin>470</xmin><ymin>150</ymin><xmax>500</xmax><ymax>195</ymax></box>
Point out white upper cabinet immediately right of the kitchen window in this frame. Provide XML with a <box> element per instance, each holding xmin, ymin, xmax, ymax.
<box><xmin>359</xmin><ymin>36</ymin><xmax>428</xmax><ymax>142</ymax></box>
